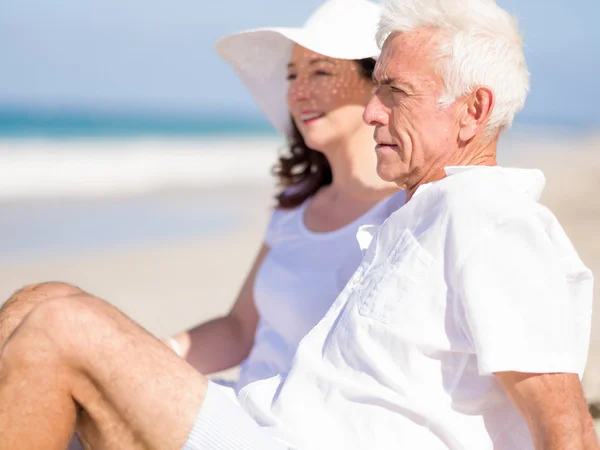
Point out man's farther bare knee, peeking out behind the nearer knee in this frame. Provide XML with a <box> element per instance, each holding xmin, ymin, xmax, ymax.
<box><xmin>0</xmin><ymin>282</ymin><xmax>84</xmax><ymax>348</ymax></box>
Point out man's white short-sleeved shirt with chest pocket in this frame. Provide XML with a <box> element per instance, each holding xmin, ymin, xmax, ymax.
<box><xmin>238</xmin><ymin>167</ymin><xmax>593</xmax><ymax>450</ymax></box>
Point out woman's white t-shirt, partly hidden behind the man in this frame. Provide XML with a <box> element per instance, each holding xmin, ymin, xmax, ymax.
<box><xmin>237</xmin><ymin>191</ymin><xmax>406</xmax><ymax>389</ymax></box>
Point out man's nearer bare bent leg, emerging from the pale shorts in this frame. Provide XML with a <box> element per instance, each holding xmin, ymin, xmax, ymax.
<box><xmin>0</xmin><ymin>284</ymin><xmax>207</xmax><ymax>450</ymax></box>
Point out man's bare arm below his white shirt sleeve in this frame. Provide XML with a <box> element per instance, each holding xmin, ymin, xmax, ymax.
<box><xmin>495</xmin><ymin>372</ymin><xmax>600</xmax><ymax>450</ymax></box>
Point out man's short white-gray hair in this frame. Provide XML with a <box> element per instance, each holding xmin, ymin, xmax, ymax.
<box><xmin>377</xmin><ymin>0</ymin><xmax>529</xmax><ymax>136</ymax></box>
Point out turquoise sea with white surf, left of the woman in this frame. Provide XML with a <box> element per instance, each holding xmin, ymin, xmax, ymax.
<box><xmin>0</xmin><ymin>108</ymin><xmax>283</xmax><ymax>199</ymax></box>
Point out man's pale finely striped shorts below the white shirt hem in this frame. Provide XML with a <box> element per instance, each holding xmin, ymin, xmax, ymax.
<box><xmin>183</xmin><ymin>381</ymin><xmax>289</xmax><ymax>450</ymax></box>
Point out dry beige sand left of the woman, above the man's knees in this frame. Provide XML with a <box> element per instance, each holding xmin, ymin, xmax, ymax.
<box><xmin>0</xmin><ymin>186</ymin><xmax>273</xmax><ymax>336</ymax></box>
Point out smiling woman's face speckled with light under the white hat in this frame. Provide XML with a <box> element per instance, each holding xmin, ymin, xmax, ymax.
<box><xmin>287</xmin><ymin>44</ymin><xmax>375</xmax><ymax>151</ymax></box>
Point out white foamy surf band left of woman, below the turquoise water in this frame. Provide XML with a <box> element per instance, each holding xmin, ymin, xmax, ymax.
<box><xmin>0</xmin><ymin>137</ymin><xmax>283</xmax><ymax>199</ymax></box>
